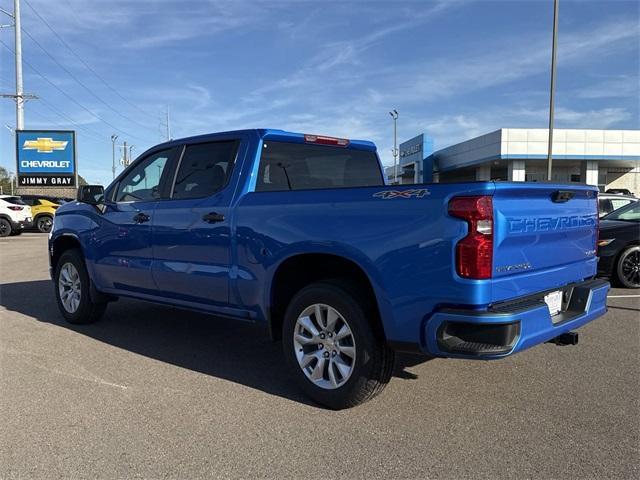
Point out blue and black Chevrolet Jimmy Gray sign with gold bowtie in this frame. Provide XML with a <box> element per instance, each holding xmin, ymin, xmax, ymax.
<box><xmin>16</xmin><ymin>130</ymin><xmax>76</xmax><ymax>187</ymax></box>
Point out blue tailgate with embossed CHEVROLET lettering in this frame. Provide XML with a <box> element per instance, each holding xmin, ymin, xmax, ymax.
<box><xmin>492</xmin><ymin>183</ymin><xmax>598</xmax><ymax>301</ymax></box>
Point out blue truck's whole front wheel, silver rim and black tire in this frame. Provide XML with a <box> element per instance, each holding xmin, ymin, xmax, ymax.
<box><xmin>54</xmin><ymin>249</ymin><xmax>107</xmax><ymax>324</ymax></box>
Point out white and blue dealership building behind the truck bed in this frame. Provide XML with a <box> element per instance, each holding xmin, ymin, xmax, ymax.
<box><xmin>386</xmin><ymin>128</ymin><xmax>640</xmax><ymax>196</ymax></box>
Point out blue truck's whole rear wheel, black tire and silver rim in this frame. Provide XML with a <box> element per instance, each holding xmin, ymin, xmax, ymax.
<box><xmin>282</xmin><ymin>281</ymin><xmax>394</xmax><ymax>410</ymax></box>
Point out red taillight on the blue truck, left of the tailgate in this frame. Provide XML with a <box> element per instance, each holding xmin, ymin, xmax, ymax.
<box><xmin>449</xmin><ymin>195</ymin><xmax>493</xmax><ymax>279</ymax></box>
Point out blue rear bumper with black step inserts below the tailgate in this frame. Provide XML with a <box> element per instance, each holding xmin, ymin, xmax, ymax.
<box><xmin>423</xmin><ymin>279</ymin><xmax>609</xmax><ymax>359</ymax></box>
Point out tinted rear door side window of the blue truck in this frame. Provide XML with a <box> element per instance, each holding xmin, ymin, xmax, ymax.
<box><xmin>172</xmin><ymin>140</ymin><xmax>239</xmax><ymax>199</ymax></box>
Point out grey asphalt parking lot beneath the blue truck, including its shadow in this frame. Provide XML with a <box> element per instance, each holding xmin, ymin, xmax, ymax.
<box><xmin>0</xmin><ymin>233</ymin><xmax>640</xmax><ymax>479</ymax></box>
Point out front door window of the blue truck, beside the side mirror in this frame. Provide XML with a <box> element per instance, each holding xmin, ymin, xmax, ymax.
<box><xmin>115</xmin><ymin>150</ymin><xmax>171</xmax><ymax>202</ymax></box>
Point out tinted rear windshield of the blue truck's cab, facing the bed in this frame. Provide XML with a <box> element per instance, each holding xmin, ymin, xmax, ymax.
<box><xmin>256</xmin><ymin>141</ymin><xmax>384</xmax><ymax>192</ymax></box>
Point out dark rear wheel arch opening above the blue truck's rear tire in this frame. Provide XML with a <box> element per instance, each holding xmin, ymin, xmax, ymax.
<box><xmin>266</xmin><ymin>252</ymin><xmax>386</xmax><ymax>340</ymax></box>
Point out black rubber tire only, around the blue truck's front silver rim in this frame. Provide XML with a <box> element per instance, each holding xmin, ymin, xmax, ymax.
<box><xmin>53</xmin><ymin>249</ymin><xmax>107</xmax><ymax>324</ymax></box>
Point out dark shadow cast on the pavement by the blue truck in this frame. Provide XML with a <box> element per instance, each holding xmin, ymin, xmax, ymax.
<box><xmin>0</xmin><ymin>280</ymin><xmax>429</xmax><ymax>405</ymax></box>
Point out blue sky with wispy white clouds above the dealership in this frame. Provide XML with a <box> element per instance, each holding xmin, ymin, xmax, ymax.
<box><xmin>0</xmin><ymin>0</ymin><xmax>640</xmax><ymax>184</ymax></box>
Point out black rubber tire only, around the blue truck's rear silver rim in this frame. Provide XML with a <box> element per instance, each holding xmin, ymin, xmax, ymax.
<box><xmin>282</xmin><ymin>280</ymin><xmax>394</xmax><ymax>410</ymax></box>
